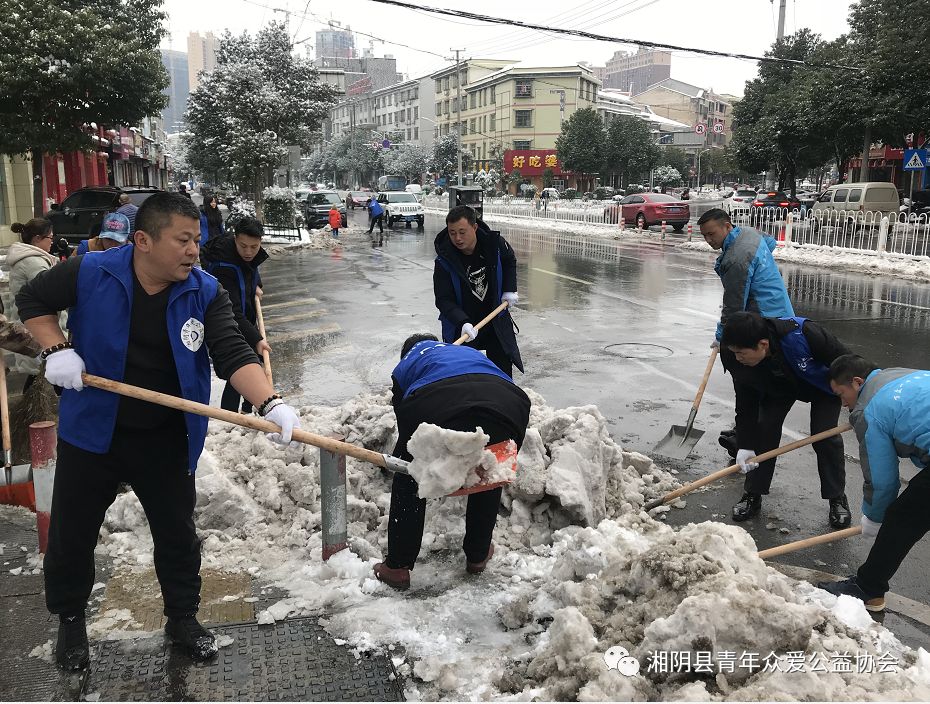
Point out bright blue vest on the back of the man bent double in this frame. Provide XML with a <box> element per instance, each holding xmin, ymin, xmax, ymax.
<box><xmin>391</xmin><ymin>340</ymin><xmax>513</xmax><ymax>398</ymax></box>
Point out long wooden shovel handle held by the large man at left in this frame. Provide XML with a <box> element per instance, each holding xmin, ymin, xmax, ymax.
<box><xmin>81</xmin><ymin>373</ymin><xmax>386</xmax><ymax>467</ymax></box>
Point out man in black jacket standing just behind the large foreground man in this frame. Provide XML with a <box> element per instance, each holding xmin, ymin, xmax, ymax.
<box><xmin>200</xmin><ymin>218</ymin><xmax>271</xmax><ymax>413</ymax></box>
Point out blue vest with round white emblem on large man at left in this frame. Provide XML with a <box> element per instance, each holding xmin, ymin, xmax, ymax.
<box><xmin>59</xmin><ymin>247</ymin><xmax>217</xmax><ymax>472</ymax></box>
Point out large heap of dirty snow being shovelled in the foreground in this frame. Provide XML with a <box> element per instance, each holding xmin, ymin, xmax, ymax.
<box><xmin>99</xmin><ymin>391</ymin><xmax>930</xmax><ymax>700</ymax></box>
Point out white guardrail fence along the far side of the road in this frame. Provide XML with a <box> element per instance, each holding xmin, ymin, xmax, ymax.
<box><xmin>423</xmin><ymin>196</ymin><xmax>930</xmax><ymax>257</ymax></box>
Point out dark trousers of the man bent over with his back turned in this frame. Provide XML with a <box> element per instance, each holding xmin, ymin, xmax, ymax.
<box><xmin>385</xmin><ymin>374</ymin><xmax>530</xmax><ymax>569</ymax></box>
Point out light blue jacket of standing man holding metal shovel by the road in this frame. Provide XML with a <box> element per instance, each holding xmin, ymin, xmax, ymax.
<box><xmin>714</xmin><ymin>227</ymin><xmax>794</xmax><ymax>341</ymax></box>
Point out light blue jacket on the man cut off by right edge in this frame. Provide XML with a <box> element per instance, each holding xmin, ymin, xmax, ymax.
<box><xmin>849</xmin><ymin>368</ymin><xmax>930</xmax><ymax>522</ymax></box>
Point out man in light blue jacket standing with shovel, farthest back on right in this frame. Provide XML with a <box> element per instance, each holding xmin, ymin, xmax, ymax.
<box><xmin>698</xmin><ymin>208</ymin><xmax>794</xmax><ymax>457</ymax></box>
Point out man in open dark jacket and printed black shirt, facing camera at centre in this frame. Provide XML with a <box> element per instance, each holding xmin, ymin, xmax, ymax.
<box><xmin>433</xmin><ymin>205</ymin><xmax>523</xmax><ymax>377</ymax></box>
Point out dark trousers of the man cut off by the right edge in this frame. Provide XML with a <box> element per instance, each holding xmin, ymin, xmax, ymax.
<box><xmin>857</xmin><ymin>468</ymin><xmax>930</xmax><ymax>597</ymax></box>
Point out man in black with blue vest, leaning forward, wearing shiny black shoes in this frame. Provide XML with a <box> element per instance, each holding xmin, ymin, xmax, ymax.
<box><xmin>721</xmin><ymin>312</ymin><xmax>850</xmax><ymax>528</ymax></box>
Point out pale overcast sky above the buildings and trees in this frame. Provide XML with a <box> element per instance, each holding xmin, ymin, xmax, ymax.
<box><xmin>163</xmin><ymin>0</ymin><xmax>854</xmax><ymax>95</ymax></box>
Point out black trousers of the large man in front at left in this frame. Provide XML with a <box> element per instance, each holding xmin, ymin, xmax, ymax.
<box><xmin>44</xmin><ymin>429</ymin><xmax>200</xmax><ymax>618</ymax></box>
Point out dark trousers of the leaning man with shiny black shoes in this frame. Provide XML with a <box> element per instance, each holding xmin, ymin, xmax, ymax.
<box><xmin>743</xmin><ymin>394</ymin><xmax>846</xmax><ymax>499</ymax></box>
